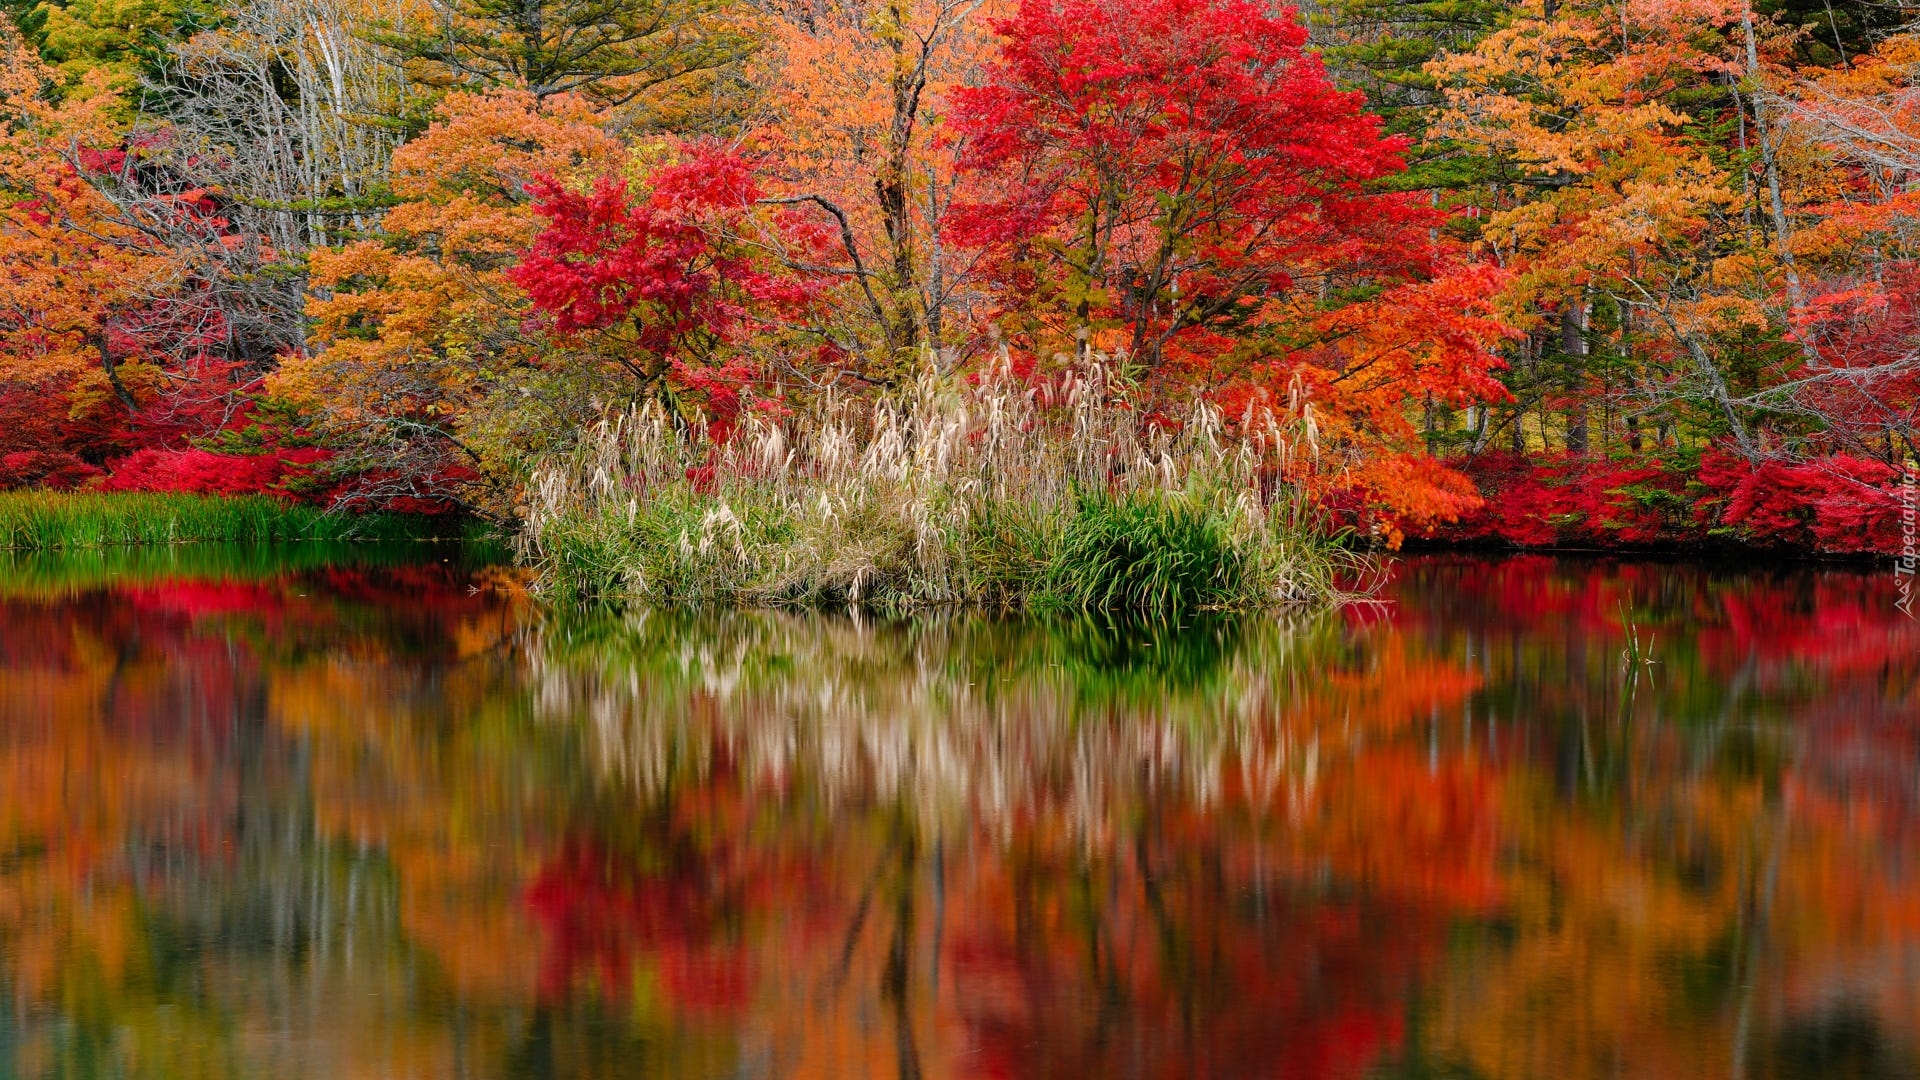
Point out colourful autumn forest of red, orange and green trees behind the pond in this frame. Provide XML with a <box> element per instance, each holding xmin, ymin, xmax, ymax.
<box><xmin>0</xmin><ymin>0</ymin><xmax>1920</xmax><ymax>564</ymax></box>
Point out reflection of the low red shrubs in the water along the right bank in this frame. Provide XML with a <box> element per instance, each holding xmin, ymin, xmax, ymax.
<box><xmin>1377</xmin><ymin>555</ymin><xmax>1920</xmax><ymax>840</ymax></box>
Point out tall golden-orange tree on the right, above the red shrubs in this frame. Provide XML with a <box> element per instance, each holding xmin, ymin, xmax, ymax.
<box><xmin>1427</xmin><ymin>0</ymin><xmax>1782</xmax><ymax>452</ymax></box>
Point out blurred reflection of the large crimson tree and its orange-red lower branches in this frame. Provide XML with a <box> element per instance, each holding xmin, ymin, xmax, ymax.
<box><xmin>917</xmin><ymin>748</ymin><xmax>1501</xmax><ymax>1078</ymax></box>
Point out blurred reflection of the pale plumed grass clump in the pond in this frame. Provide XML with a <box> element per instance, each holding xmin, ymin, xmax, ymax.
<box><xmin>524</xmin><ymin>609</ymin><xmax>1348</xmax><ymax>828</ymax></box>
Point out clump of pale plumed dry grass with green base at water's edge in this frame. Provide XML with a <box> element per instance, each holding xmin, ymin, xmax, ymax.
<box><xmin>520</xmin><ymin>355</ymin><xmax>1354</xmax><ymax>615</ymax></box>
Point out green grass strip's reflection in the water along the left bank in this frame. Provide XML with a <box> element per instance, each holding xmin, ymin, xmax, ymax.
<box><xmin>0</xmin><ymin>540</ymin><xmax>507</xmax><ymax>600</ymax></box>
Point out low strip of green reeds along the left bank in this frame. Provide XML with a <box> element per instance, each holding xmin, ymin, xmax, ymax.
<box><xmin>0</xmin><ymin>492</ymin><xmax>444</xmax><ymax>552</ymax></box>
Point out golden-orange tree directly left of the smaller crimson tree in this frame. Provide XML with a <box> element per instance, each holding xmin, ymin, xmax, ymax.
<box><xmin>269</xmin><ymin>90</ymin><xmax>632</xmax><ymax>509</ymax></box>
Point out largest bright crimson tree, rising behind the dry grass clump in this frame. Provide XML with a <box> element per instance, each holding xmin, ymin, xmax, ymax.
<box><xmin>947</xmin><ymin>0</ymin><xmax>1425</xmax><ymax>388</ymax></box>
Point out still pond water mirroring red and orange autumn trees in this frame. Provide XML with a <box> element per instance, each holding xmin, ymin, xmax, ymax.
<box><xmin>0</xmin><ymin>546</ymin><xmax>1920</xmax><ymax>1080</ymax></box>
